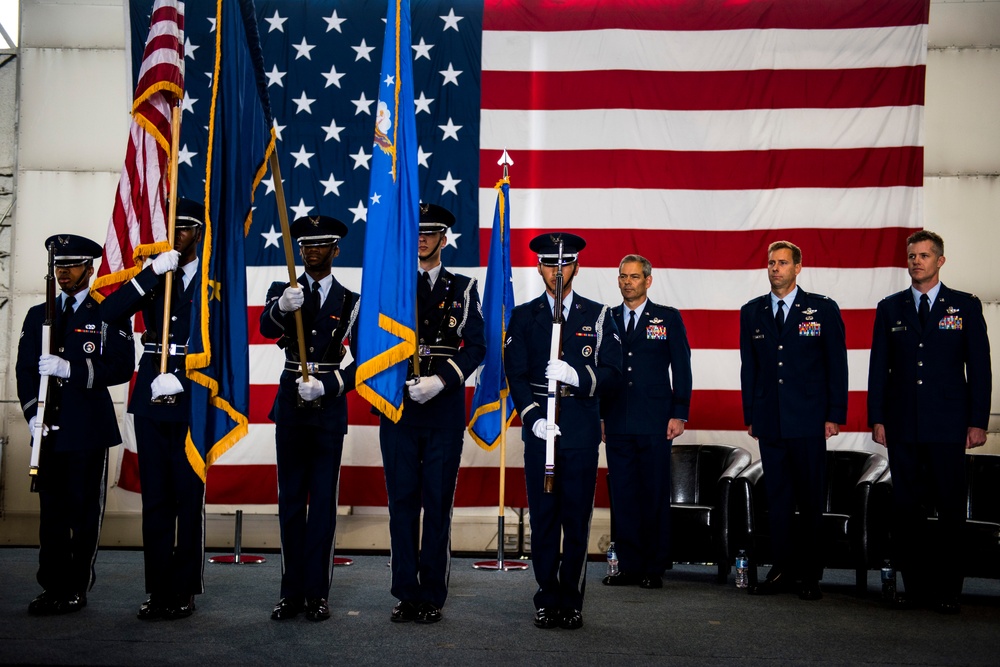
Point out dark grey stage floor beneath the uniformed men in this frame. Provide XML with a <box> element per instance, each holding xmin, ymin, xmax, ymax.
<box><xmin>0</xmin><ymin>548</ymin><xmax>1000</xmax><ymax>667</ymax></box>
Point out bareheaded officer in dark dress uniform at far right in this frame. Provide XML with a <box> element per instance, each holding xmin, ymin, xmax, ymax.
<box><xmin>868</xmin><ymin>230</ymin><xmax>993</xmax><ymax>614</ymax></box>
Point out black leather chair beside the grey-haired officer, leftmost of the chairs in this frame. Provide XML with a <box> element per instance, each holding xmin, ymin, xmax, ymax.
<box><xmin>670</xmin><ymin>444</ymin><xmax>752</xmax><ymax>583</ymax></box>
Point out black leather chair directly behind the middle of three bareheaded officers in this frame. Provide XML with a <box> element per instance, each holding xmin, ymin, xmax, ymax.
<box><xmin>729</xmin><ymin>450</ymin><xmax>889</xmax><ymax>593</ymax></box>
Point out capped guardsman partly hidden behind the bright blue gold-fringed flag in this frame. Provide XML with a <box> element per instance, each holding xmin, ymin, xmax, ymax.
<box><xmin>374</xmin><ymin>204</ymin><xmax>486</xmax><ymax>623</ymax></box>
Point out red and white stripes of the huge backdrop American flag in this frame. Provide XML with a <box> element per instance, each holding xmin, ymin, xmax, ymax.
<box><xmin>115</xmin><ymin>0</ymin><xmax>928</xmax><ymax>506</ymax></box>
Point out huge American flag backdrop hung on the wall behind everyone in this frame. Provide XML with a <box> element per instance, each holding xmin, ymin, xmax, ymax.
<box><xmin>119</xmin><ymin>0</ymin><xmax>929</xmax><ymax>506</ymax></box>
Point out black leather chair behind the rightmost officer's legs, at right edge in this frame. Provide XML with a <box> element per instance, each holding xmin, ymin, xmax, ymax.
<box><xmin>876</xmin><ymin>454</ymin><xmax>1000</xmax><ymax>579</ymax></box>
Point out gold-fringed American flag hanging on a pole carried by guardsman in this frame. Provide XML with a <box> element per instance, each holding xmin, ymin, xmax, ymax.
<box><xmin>92</xmin><ymin>0</ymin><xmax>184</xmax><ymax>300</ymax></box>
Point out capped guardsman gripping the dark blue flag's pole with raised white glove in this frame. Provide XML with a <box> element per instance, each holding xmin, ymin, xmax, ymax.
<box><xmin>260</xmin><ymin>215</ymin><xmax>359</xmax><ymax>621</ymax></box>
